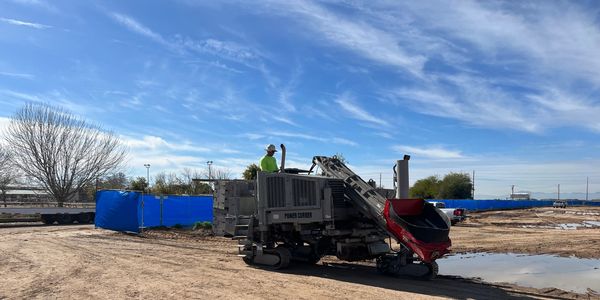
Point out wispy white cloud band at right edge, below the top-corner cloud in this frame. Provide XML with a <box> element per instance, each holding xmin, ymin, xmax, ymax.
<box><xmin>381</xmin><ymin>75</ymin><xmax>600</xmax><ymax>133</ymax></box>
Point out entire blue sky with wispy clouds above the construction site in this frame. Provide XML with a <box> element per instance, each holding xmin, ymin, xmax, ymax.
<box><xmin>0</xmin><ymin>0</ymin><xmax>600</xmax><ymax>197</ymax></box>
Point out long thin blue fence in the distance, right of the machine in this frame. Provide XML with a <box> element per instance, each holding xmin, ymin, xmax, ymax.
<box><xmin>429</xmin><ymin>199</ymin><xmax>600</xmax><ymax>211</ymax></box>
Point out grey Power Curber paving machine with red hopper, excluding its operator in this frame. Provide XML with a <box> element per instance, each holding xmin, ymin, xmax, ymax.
<box><xmin>233</xmin><ymin>145</ymin><xmax>451</xmax><ymax>280</ymax></box>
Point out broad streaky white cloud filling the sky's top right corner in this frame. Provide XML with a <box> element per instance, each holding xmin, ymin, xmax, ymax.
<box><xmin>414</xmin><ymin>1</ymin><xmax>600</xmax><ymax>83</ymax></box>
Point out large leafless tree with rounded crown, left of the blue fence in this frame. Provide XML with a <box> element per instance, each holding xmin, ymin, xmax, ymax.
<box><xmin>6</xmin><ymin>104</ymin><xmax>125</xmax><ymax>206</ymax></box>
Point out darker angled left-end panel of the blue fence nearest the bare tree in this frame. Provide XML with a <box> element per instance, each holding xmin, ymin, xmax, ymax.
<box><xmin>95</xmin><ymin>191</ymin><xmax>140</xmax><ymax>232</ymax></box>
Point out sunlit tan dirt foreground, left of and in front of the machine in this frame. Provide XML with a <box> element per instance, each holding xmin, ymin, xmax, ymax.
<box><xmin>0</xmin><ymin>227</ymin><xmax>592</xmax><ymax>299</ymax></box>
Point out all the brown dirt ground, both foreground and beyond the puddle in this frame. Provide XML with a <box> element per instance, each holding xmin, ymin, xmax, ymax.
<box><xmin>0</xmin><ymin>208</ymin><xmax>600</xmax><ymax>299</ymax></box>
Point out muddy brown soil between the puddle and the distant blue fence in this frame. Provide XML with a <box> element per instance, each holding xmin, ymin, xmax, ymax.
<box><xmin>450</xmin><ymin>207</ymin><xmax>600</xmax><ymax>258</ymax></box>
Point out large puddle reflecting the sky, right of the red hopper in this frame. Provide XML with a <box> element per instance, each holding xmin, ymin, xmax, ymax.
<box><xmin>437</xmin><ymin>253</ymin><xmax>600</xmax><ymax>293</ymax></box>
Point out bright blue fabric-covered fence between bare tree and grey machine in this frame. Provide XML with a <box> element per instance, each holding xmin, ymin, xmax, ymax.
<box><xmin>95</xmin><ymin>190</ymin><xmax>213</xmax><ymax>232</ymax></box>
